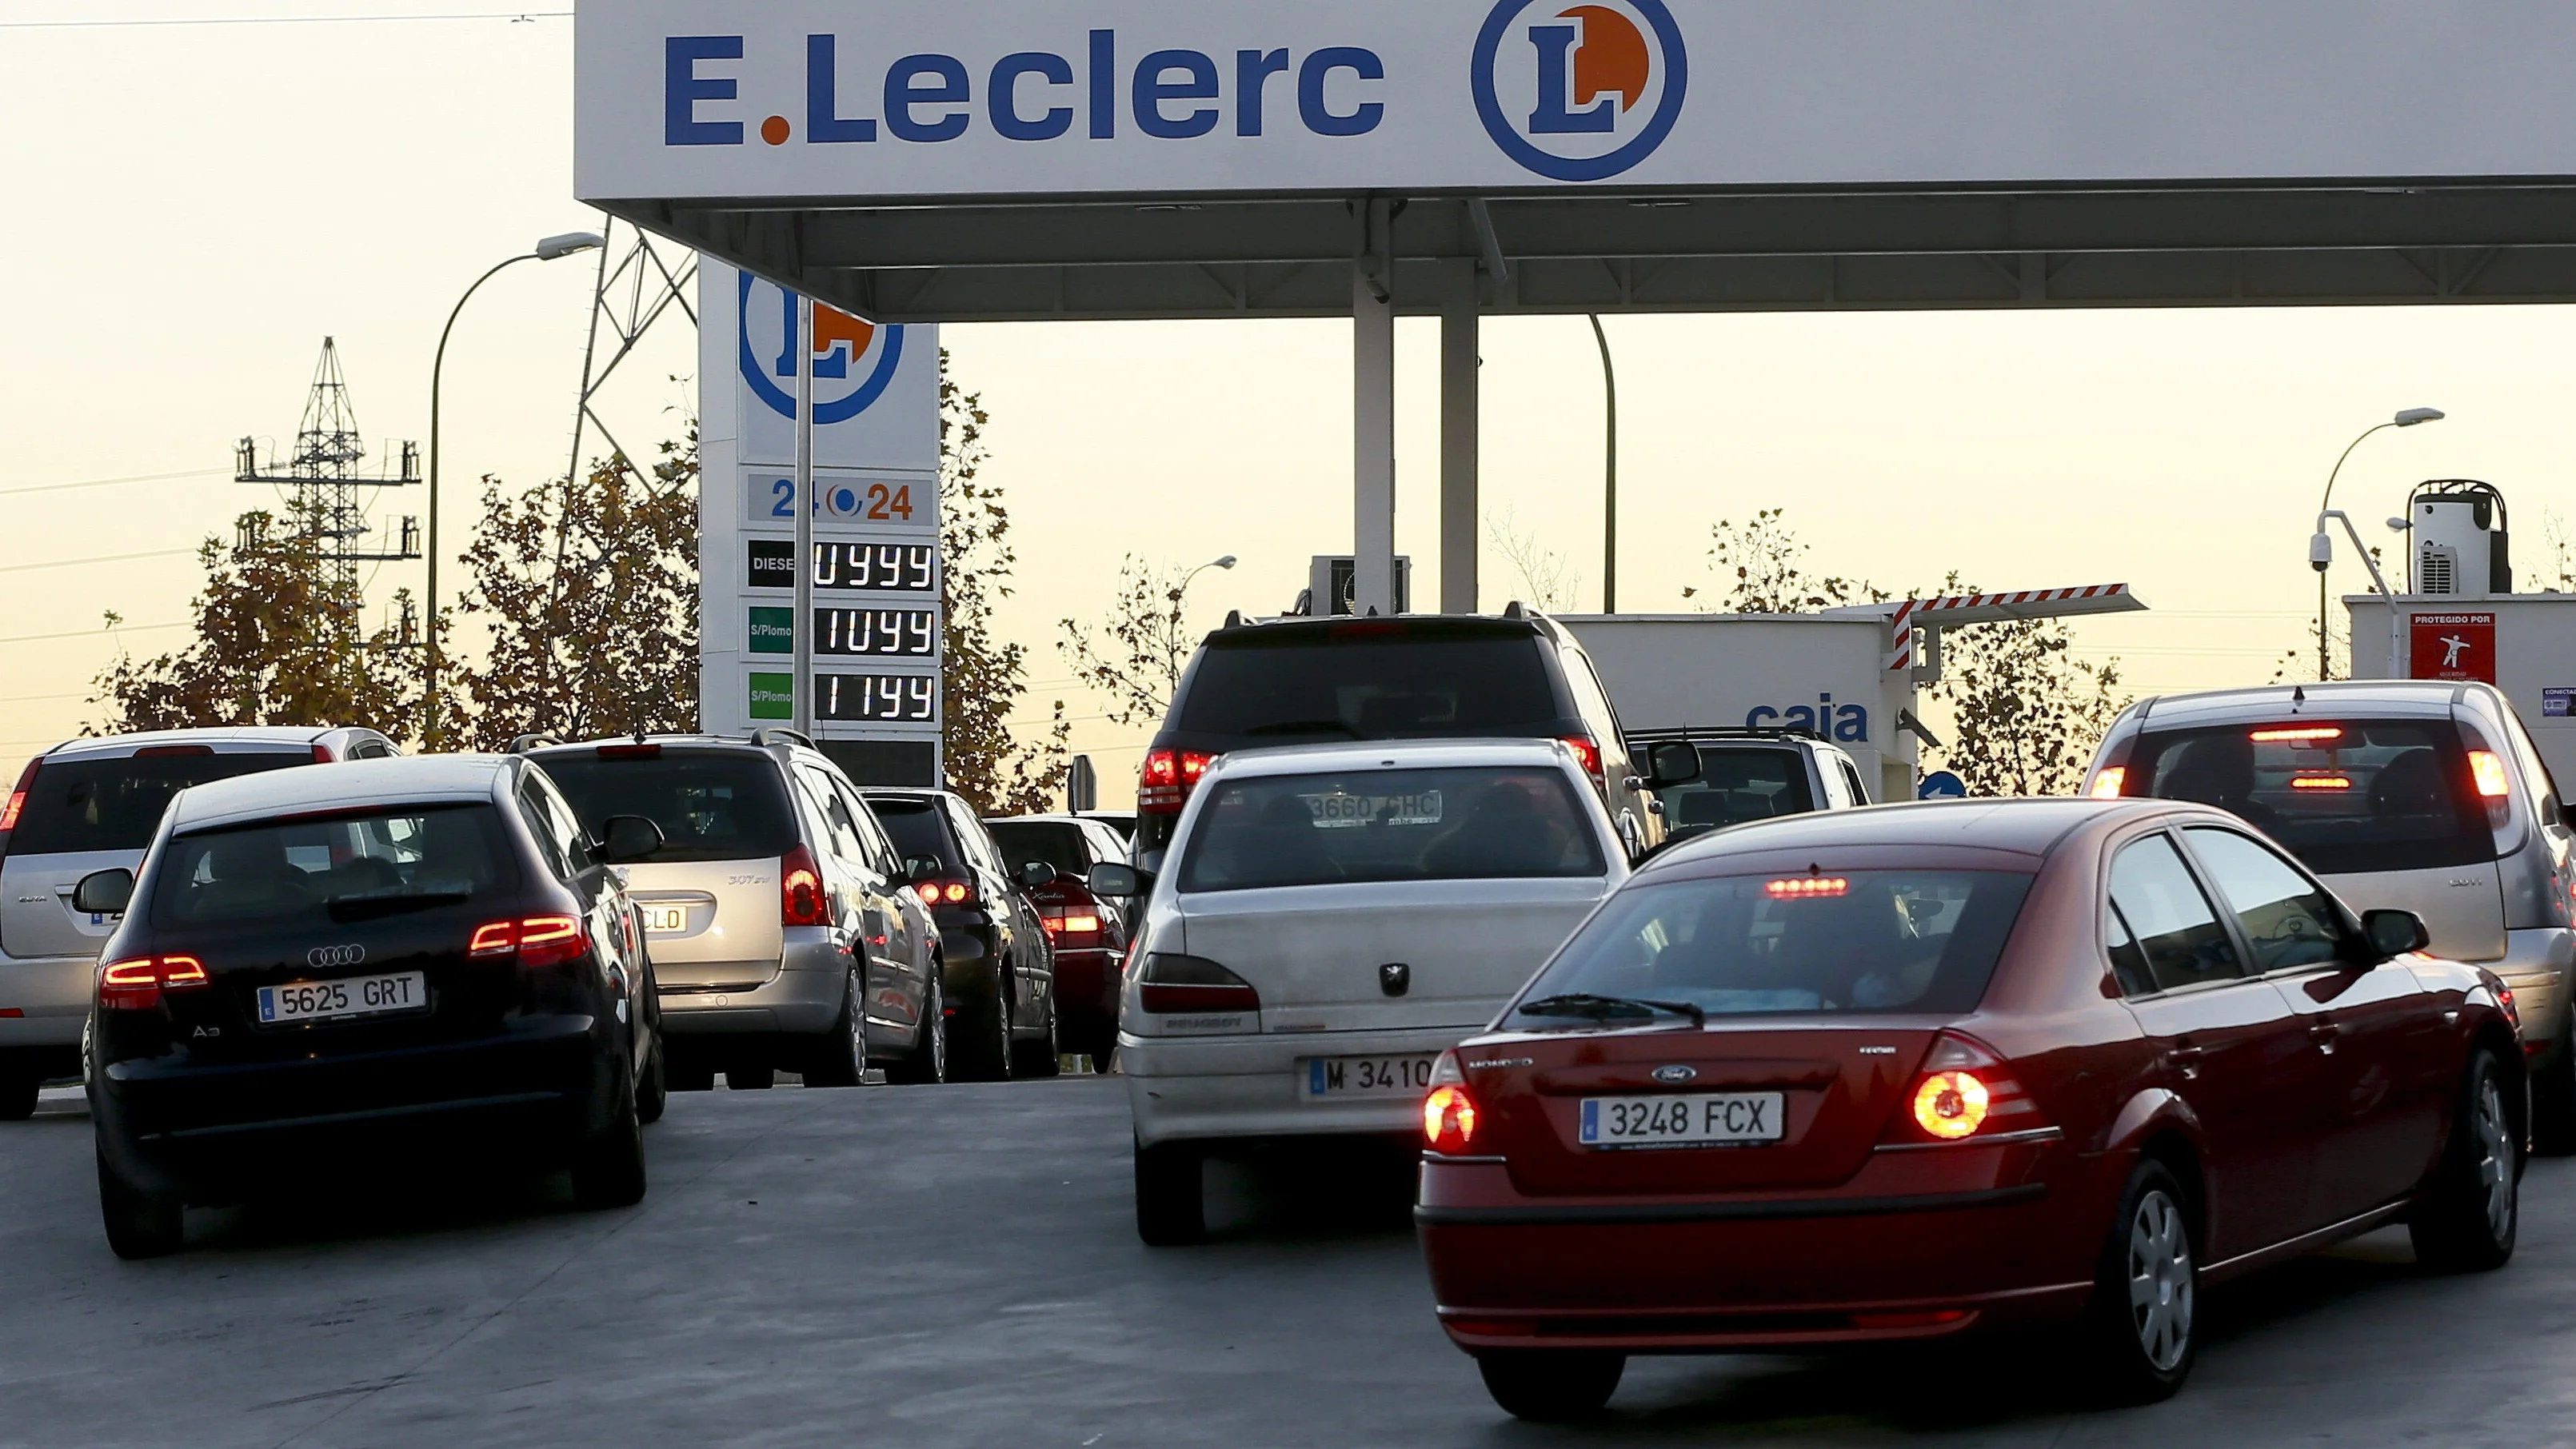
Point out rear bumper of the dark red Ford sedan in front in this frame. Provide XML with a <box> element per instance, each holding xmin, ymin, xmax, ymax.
<box><xmin>1414</xmin><ymin>1143</ymin><xmax>2128</xmax><ymax>1354</ymax></box>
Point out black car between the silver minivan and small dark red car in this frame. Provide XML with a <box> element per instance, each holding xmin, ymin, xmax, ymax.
<box><xmin>865</xmin><ymin>788</ymin><xmax>1056</xmax><ymax>1081</ymax></box>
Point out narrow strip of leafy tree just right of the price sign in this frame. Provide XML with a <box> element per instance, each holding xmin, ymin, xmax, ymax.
<box><xmin>941</xmin><ymin>350</ymin><xmax>1074</xmax><ymax>816</ymax></box>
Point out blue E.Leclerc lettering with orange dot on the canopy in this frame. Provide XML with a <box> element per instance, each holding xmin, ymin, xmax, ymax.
<box><xmin>662</xmin><ymin>31</ymin><xmax>1386</xmax><ymax>146</ymax></box>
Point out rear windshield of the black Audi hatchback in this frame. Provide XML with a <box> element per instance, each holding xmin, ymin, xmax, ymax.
<box><xmin>152</xmin><ymin>805</ymin><xmax>517</xmax><ymax>927</ymax></box>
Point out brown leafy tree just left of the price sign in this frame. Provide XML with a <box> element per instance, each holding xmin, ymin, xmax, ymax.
<box><xmin>441</xmin><ymin>429</ymin><xmax>698</xmax><ymax>749</ymax></box>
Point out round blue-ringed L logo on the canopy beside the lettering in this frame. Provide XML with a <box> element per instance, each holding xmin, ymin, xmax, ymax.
<box><xmin>1471</xmin><ymin>0</ymin><xmax>1690</xmax><ymax>180</ymax></box>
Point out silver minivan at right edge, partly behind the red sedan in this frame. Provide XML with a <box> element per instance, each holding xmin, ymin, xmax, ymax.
<box><xmin>2087</xmin><ymin>680</ymin><xmax>2576</xmax><ymax>1153</ymax></box>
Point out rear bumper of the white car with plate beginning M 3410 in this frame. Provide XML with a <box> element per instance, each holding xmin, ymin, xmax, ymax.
<box><xmin>1118</xmin><ymin>1027</ymin><xmax>1484</xmax><ymax>1145</ymax></box>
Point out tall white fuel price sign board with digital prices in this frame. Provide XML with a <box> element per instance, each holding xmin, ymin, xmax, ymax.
<box><xmin>698</xmin><ymin>260</ymin><xmax>943</xmax><ymax>780</ymax></box>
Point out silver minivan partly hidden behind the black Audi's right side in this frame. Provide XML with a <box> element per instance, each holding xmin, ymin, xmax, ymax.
<box><xmin>523</xmin><ymin>728</ymin><xmax>948</xmax><ymax>1092</ymax></box>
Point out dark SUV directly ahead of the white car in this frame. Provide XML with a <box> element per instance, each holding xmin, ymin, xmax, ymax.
<box><xmin>1136</xmin><ymin>605</ymin><xmax>1679</xmax><ymax>868</ymax></box>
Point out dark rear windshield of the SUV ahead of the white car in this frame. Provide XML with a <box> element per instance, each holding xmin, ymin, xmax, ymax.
<box><xmin>1169</xmin><ymin>623</ymin><xmax>1564</xmax><ymax>741</ymax></box>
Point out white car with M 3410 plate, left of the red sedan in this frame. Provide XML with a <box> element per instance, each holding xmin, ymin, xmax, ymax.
<box><xmin>1092</xmin><ymin>739</ymin><xmax>1628</xmax><ymax>1246</ymax></box>
